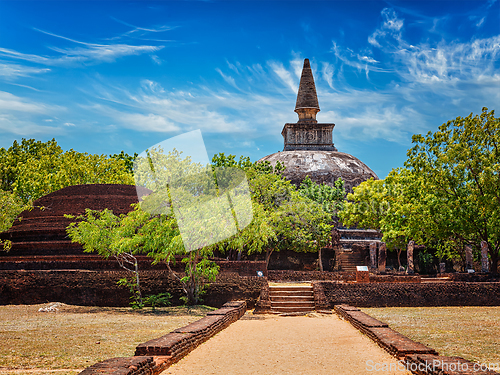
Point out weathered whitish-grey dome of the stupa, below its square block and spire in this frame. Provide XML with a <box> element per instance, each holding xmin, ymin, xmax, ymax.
<box><xmin>259</xmin><ymin>150</ymin><xmax>378</xmax><ymax>192</ymax></box>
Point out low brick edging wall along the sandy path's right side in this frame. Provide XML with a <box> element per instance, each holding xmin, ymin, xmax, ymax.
<box><xmin>334</xmin><ymin>305</ymin><xmax>498</xmax><ymax>375</ymax></box>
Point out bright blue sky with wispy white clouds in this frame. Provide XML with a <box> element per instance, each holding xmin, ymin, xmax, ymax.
<box><xmin>0</xmin><ymin>0</ymin><xmax>500</xmax><ymax>178</ymax></box>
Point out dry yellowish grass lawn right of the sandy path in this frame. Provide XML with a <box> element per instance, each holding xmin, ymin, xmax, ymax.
<box><xmin>362</xmin><ymin>307</ymin><xmax>500</xmax><ymax>371</ymax></box>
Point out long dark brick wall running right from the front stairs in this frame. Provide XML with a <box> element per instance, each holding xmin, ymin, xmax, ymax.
<box><xmin>313</xmin><ymin>281</ymin><xmax>500</xmax><ymax>308</ymax></box>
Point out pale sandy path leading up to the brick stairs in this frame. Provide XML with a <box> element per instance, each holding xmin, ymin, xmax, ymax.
<box><xmin>162</xmin><ymin>312</ymin><xmax>411</xmax><ymax>375</ymax></box>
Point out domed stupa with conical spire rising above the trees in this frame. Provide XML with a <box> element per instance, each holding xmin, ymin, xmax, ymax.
<box><xmin>259</xmin><ymin>59</ymin><xmax>378</xmax><ymax>192</ymax></box>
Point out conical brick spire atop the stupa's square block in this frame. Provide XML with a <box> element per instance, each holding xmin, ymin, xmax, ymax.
<box><xmin>295</xmin><ymin>59</ymin><xmax>320</xmax><ymax>122</ymax></box>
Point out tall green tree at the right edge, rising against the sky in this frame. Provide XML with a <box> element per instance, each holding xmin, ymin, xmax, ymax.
<box><xmin>405</xmin><ymin>108</ymin><xmax>500</xmax><ymax>273</ymax></box>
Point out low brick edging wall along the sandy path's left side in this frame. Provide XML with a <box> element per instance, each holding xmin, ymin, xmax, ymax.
<box><xmin>80</xmin><ymin>301</ymin><xmax>246</xmax><ymax>375</ymax></box>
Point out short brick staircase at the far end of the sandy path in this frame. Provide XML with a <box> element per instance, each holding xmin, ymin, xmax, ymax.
<box><xmin>269</xmin><ymin>283</ymin><xmax>314</xmax><ymax>314</ymax></box>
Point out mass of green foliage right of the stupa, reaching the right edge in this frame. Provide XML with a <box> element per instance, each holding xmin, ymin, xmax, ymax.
<box><xmin>339</xmin><ymin>108</ymin><xmax>500</xmax><ymax>272</ymax></box>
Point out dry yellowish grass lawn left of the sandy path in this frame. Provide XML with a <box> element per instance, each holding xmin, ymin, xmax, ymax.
<box><xmin>0</xmin><ymin>303</ymin><xmax>211</xmax><ymax>375</ymax></box>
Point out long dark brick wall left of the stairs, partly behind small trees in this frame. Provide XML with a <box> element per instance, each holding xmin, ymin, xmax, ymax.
<box><xmin>0</xmin><ymin>270</ymin><xmax>267</xmax><ymax>307</ymax></box>
